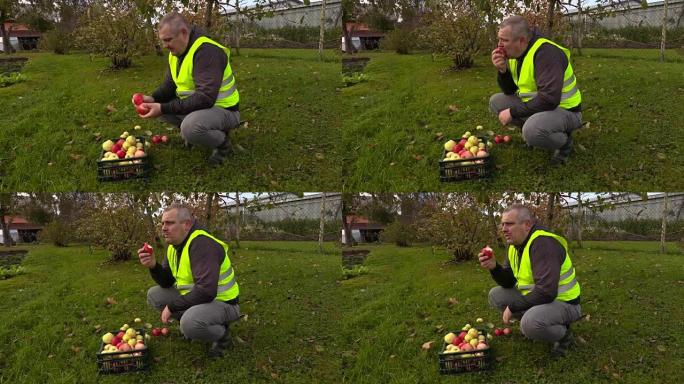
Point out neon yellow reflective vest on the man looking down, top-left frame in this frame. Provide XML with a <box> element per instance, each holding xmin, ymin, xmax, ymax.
<box><xmin>169</xmin><ymin>36</ymin><xmax>240</xmax><ymax>108</ymax></box>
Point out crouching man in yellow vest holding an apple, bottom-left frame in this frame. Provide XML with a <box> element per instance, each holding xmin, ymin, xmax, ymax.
<box><xmin>138</xmin><ymin>205</ymin><xmax>240</xmax><ymax>357</ymax></box>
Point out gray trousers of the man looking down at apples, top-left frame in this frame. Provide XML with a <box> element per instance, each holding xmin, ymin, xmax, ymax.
<box><xmin>159</xmin><ymin>107</ymin><xmax>240</xmax><ymax>148</ymax></box>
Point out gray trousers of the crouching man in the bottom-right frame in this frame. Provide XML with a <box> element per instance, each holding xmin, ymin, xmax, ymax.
<box><xmin>489</xmin><ymin>286</ymin><xmax>582</xmax><ymax>343</ymax></box>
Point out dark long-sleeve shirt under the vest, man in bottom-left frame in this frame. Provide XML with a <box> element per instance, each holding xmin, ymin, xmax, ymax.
<box><xmin>150</xmin><ymin>224</ymin><xmax>237</xmax><ymax>312</ymax></box>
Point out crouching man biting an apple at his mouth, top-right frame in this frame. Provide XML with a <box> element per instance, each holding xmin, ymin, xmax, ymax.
<box><xmin>489</xmin><ymin>16</ymin><xmax>582</xmax><ymax>165</ymax></box>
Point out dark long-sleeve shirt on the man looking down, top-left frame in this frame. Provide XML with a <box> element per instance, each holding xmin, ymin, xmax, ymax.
<box><xmin>152</xmin><ymin>26</ymin><xmax>239</xmax><ymax>115</ymax></box>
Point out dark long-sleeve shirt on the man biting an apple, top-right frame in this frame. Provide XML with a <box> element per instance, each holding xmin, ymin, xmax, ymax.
<box><xmin>496</xmin><ymin>34</ymin><xmax>582</xmax><ymax>118</ymax></box>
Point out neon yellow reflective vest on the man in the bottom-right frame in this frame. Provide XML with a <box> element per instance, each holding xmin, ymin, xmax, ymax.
<box><xmin>508</xmin><ymin>230</ymin><xmax>580</xmax><ymax>301</ymax></box>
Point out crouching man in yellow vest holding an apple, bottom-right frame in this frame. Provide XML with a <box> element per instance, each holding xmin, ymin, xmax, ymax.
<box><xmin>478</xmin><ymin>204</ymin><xmax>582</xmax><ymax>357</ymax></box>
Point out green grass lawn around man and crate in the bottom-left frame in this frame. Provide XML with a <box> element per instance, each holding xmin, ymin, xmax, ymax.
<box><xmin>0</xmin><ymin>242</ymin><xmax>347</xmax><ymax>383</ymax></box>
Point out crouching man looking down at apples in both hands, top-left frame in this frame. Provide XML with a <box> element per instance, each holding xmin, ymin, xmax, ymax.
<box><xmin>131</xmin><ymin>12</ymin><xmax>240</xmax><ymax>165</ymax></box>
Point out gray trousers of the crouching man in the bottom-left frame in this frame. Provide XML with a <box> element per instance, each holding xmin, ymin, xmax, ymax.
<box><xmin>147</xmin><ymin>285</ymin><xmax>240</xmax><ymax>342</ymax></box>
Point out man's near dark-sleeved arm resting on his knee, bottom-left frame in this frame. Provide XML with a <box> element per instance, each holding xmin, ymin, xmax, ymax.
<box><xmin>168</xmin><ymin>236</ymin><xmax>225</xmax><ymax>312</ymax></box>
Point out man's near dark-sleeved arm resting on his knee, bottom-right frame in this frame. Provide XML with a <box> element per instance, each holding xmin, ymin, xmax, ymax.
<box><xmin>510</xmin><ymin>236</ymin><xmax>565</xmax><ymax>313</ymax></box>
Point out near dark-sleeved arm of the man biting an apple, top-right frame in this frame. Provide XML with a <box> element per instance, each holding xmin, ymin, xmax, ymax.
<box><xmin>511</xmin><ymin>43</ymin><xmax>568</xmax><ymax>118</ymax></box>
